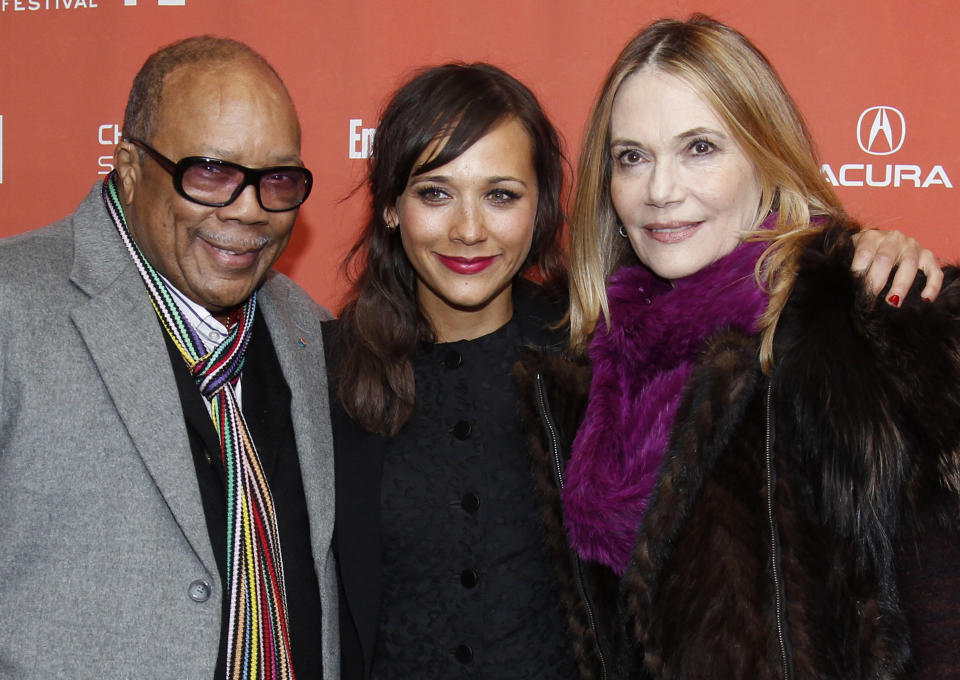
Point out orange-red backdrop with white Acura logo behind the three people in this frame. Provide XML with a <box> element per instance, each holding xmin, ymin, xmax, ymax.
<box><xmin>0</xmin><ymin>0</ymin><xmax>960</xmax><ymax>309</ymax></box>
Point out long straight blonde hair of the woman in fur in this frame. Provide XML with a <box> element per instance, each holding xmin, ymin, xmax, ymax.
<box><xmin>570</xmin><ymin>14</ymin><xmax>843</xmax><ymax>367</ymax></box>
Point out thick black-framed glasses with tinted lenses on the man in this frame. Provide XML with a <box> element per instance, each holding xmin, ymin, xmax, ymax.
<box><xmin>126</xmin><ymin>138</ymin><xmax>313</xmax><ymax>212</ymax></box>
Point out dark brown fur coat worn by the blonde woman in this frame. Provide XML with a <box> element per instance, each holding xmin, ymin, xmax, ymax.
<box><xmin>516</xmin><ymin>224</ymin><xmax>960</xmax><ymax>680</ymax></box>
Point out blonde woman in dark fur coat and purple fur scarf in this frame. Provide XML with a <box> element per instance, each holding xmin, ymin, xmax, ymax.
<box><xmin>525</xmin><ymin>16</ymin><xmax>960</xmax><ymax>678</ymax></box>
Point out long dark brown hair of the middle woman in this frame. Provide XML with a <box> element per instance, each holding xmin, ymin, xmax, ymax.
<box><xmin>337</xmin><ymin>63</ymin><xmax>566</xmax><ymax>436</ymax></box>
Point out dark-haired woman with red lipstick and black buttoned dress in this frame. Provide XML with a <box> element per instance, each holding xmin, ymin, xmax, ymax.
<box><xmin>325</xmin><ymin>64</ymin><xmax>576</xmax><ymax>678</ymax></box>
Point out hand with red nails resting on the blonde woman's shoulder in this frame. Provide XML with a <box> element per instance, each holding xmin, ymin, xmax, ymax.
<box><xmin>851</xmin><ymin>229</ymin><xmax>943</xmax><ymax>307</ymax></box>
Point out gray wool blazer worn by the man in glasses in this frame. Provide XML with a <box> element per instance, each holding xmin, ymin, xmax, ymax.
<box><xmin>0</xmin><ymin>183</ymin><xmax>339</xmax><ymax>680</ymax></box>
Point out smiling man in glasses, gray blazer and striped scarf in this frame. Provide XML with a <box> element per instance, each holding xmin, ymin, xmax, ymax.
<box><xmin>0</xmin><ymin>37</ymin><xmax>338</xmax><ymax>679</ymax></box>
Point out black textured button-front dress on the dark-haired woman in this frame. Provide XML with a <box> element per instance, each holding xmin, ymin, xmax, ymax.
<box><xmin>372</xmin><ymin>322</ymin><xmax>576</xmax><ymax>680</ymax></box>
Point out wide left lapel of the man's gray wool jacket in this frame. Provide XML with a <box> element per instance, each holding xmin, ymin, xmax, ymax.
<box><xmin>71</xmin><ymin>184</ymin><xmax>218</xmax><ymax>578</ymax></box>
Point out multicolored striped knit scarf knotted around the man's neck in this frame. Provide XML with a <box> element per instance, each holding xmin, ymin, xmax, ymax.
<box><xmin>103</xmin><ymin>174</ymin><xmax>294</xmax><ymax>680</ymax></box>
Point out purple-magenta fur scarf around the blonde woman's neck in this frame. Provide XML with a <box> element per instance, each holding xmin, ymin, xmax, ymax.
<box><xmin>563</xmin><ymin>236</ymin><xmax>769</xmax><ymax>575</ymax></box>
